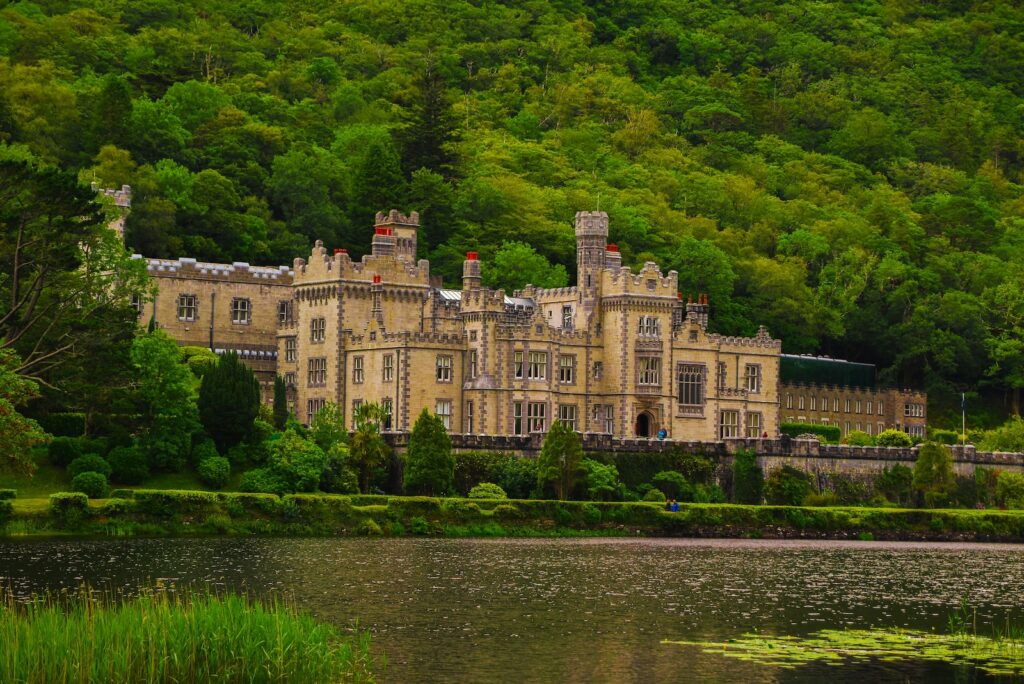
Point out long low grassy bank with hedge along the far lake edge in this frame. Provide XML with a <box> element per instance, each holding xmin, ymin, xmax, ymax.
<box><xmin>3</xmin><ymin>489</ymin><xmax>1024</xmax><ymax>542</ymax></box>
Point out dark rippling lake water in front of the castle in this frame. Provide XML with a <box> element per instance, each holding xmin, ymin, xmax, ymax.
<box><xmin>0</xmin><ymin>539</ymin><xmax>1024</xmax><ymax>682</ymax></box>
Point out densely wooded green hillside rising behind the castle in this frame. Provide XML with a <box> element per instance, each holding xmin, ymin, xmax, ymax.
<box><xmin>0</xmin><ymin>0</ymin><xmax>1024</xmax><ymax>421</ymax></box>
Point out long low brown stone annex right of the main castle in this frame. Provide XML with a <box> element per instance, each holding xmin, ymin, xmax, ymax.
<box><xmin>779</xmin><ymin>382</ymin><xmax>928</xmax><ymax>437</ymax></box>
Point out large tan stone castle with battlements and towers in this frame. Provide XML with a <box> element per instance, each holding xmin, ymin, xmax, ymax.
<box><xmin>130</xmin><ymin>211</ymin><xmax>781</xmax><ymax>440</ymax></box>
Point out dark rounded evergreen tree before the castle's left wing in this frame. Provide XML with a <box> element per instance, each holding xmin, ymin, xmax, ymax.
<box><xmin>199</xmin><ymin>351</ymin><xmax>259</xmax><ymax>454</ymax></box>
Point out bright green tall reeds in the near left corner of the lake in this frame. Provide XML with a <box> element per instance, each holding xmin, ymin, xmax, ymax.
<box><xmin>0</xmin><ymin>591</ymin><xmax>374</xmax><ymax>683</ymax></box>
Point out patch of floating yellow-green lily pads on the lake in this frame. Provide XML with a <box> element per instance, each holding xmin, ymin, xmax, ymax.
<box><xmin>662</xmin><ymin>605</ymin><xmax>1024</xmax><ymax>676</ymax></box>
